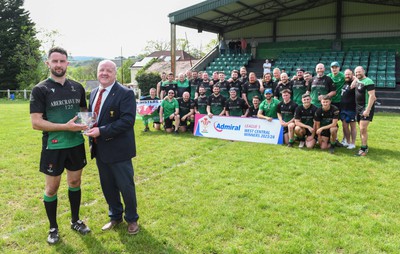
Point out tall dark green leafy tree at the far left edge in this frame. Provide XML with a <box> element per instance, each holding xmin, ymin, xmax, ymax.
<box><xmin>0</xmin><ymin>0</ymin><xmax>43</xmax><ymax>89</ymax></box>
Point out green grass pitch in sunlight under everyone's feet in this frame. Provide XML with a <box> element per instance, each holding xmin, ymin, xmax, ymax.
<box><xmin>0</xmin><ymin>101</ymin><xmax>400</xmax><ymax>253</ymax></box>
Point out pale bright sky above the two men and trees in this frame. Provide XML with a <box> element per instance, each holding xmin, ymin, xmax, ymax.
<box><xmin>23</xmin><ymin>0</ymin><xmax>217</xmax><ymax>59</ymax></box>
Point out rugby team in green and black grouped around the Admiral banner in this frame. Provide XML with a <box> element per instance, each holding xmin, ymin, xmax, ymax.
<box><xmin>145</xmin><ymin>62</ymin><xmax>376</xmax><ymax>156</ymax></box>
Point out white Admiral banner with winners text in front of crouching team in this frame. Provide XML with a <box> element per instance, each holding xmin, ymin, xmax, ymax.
<box><xmin>193</xmin><ymin>114</ymin><xmax>283</xmax><ymax>144</ymax></box>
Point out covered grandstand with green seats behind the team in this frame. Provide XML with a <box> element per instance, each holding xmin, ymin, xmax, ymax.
<box><xmin>169</xmin><ymin>0</ymin><xmax>400</xmax><ymax>112</ymax></box>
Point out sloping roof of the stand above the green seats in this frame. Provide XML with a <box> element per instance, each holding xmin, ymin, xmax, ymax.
<box><xmin>168</xmin><ymin>0</ymin><xmax>400</xmax><ymax>34</ymax></box>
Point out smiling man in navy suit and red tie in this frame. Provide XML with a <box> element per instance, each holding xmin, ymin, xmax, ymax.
<box><xmin>86</xmin><ymin>60</ymin><xmax>139</xmax><ymax>234</ymax></box>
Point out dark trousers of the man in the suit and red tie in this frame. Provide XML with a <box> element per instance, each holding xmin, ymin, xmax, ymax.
<box><xmin>96</xmin><ymin>159</ymin><xmax>139</xmax><ymax>223</ymax></box>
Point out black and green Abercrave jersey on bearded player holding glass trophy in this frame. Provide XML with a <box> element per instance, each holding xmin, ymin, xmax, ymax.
<box><xmin>30</xmin><ymin>78</ymin><xmax>87</xmax><ymax>150</ymax></box>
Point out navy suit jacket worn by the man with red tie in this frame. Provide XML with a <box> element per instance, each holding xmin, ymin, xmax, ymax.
<box><xmin>89</xmin><ymin>82</ymin><xmax>136</xmax><ymax>163</ymax></box>
